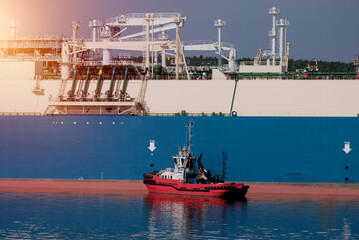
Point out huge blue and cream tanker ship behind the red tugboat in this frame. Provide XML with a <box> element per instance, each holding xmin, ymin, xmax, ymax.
<box><xmin>0</xmin><ymin>9</ymin><xmax>359</xmax><ymax>189</ymax></box>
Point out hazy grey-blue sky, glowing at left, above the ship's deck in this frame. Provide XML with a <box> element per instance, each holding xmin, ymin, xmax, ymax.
<box><xmin>0</xmin><ymin>0</ymin><xmax>359</xmax><ymax>62</ymax></box>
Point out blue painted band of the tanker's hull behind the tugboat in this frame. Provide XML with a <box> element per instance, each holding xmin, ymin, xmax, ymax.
<box><xmin>0</xmin><ymin>116</ymin><xmax>359</xmax><ymax>183</ymax></box>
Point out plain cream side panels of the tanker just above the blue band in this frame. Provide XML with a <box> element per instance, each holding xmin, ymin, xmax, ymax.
<box><xmin>0</xmin><ymin>75</ymin><xmax>359</xmax><ymax>116</ymax></box>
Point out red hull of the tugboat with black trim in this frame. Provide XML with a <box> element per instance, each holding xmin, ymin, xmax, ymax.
<box><xmin>143</xmin><ymin>173</ymin><xmax>249</xmax><ymax>199</ymax></box>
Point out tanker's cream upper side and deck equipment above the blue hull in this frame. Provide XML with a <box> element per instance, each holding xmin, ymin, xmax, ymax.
<box><xmin>0</xmin><ymin>8</ymin><xmax>359</xmax><ymax>116</ymax></box>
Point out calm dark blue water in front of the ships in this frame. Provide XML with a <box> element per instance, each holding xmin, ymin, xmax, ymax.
<box><xmin>0</xmin><ymin>189</ymin><xmax>359</xmax><ymax>239</ymax></box>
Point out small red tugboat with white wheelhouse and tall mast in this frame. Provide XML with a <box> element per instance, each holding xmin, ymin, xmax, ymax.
<box><xmin>143</xmin><ymin>121</ymin><xmax>249</xmax><ymax>199</ymax></box>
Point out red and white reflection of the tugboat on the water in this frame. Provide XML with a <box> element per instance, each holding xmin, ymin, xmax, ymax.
<box><xmin>145</xmin><ymin>193</ymin><xmax>246</xmax><ymax>239</ymax></box>
